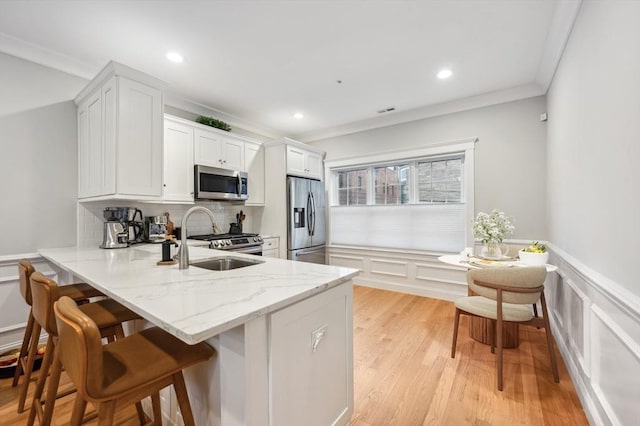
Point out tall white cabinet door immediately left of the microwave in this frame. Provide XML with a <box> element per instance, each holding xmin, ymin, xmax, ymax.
<box><xmin>162</xmin><ymin>120</ymin><xmax>194</xmax><ymax>202</ymax></box>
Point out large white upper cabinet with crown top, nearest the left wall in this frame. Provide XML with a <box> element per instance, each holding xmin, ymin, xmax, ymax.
<box><xmin>75</xmin><ymin>62</ymin><xmax>164</xmax><ymax>200</ymax></box>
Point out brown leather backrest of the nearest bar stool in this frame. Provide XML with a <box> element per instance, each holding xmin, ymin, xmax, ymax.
<box><xmin>54</xmin><ymin>296</ymin><xmax>103</xmax><ymax>400</ymax></box>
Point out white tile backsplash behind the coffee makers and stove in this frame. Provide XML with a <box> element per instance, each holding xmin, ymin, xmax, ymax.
<box><xmin>78</xmin><ymin>200</ymin><xmax>262</xmax><ymax>247</ymax></box>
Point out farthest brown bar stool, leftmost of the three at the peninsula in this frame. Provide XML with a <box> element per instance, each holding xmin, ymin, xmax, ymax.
<box><xmin>11</xmin><ymin>259</ymin><xmax>104</xmax><ymax>413</ymax></box>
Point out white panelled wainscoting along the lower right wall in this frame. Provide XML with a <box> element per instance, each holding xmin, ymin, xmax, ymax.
<box><xmin>545</xmin><ymin>244</ymin><xmax>640</xmax><ymax>425</ymax></box>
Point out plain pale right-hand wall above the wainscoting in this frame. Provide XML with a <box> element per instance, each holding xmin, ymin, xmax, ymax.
<box><xmin>547</xmin><ymin>1</ymin><xmax>640</xmax><ymax>296</ymax></box>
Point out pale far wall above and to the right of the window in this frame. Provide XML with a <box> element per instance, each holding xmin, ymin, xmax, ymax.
<box><xmin>310</xmin><ymin>96</ymin><xmax>547</xmax><ymax>240</ymax></box>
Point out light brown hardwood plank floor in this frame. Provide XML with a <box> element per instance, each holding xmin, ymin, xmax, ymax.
<box><xmin>0</xmin><ymin>286</ymin><xmax>588</xmax><ymax>426</ymax></box>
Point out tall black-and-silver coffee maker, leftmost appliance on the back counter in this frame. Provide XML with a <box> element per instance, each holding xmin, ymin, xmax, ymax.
<box><xmin>100</xmin><ymin>207</ymin><xmax>144</xmax><ymax>248</ymax></box>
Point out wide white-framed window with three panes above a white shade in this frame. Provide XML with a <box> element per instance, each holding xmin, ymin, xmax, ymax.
<box><xmin>326</xmin><ymin>138</ymin><xmax>477</xmax><ymax>253</ymax></box>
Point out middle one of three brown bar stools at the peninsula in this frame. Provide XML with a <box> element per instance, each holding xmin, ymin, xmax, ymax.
<box><xmin>27</xmin><ymin>272</ymin><xmax>142</xmax><ymax>426</ymax></box>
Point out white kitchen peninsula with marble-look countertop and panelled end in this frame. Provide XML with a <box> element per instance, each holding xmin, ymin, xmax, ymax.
<box><xmin>39</xmin><ymin>245</ymin><xmax>358</xmax><ymax>426</ymax></box>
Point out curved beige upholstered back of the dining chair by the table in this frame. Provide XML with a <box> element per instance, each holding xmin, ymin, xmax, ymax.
<box><xmin>467</xmin><ymin>266</ymin><xmax>547</xmax><ymax>305</ymax></box>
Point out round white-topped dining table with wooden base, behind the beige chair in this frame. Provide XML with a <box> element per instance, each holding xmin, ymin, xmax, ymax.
<box><xmin>438</xmin><ymin>254</ymin><xmax>558</xmax><ymax>349</ymax></box>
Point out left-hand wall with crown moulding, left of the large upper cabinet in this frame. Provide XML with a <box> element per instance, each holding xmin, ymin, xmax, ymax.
<box><xmin>0</xmin><ymin>54</ymin><xmax>86</xmax><ymax>256</ymax></box>
